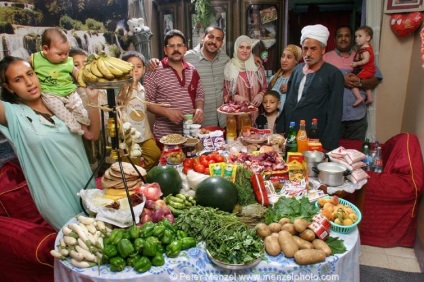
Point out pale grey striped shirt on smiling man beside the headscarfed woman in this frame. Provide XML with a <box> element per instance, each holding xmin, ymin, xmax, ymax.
<box><xmin>184</xmin><ymin>44</ymin><xmax>230</xmax><ymax>127</ymax></box>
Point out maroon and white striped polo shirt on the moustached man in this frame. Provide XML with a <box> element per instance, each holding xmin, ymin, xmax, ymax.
<box><xmin>143</xmin><ymin>57</ymin><xmax>205</xmax><ymax>140</ymax></box>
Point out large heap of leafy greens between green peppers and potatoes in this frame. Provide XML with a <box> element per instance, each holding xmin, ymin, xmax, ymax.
<box><xmin>175</xmin><ymin>206</ymin><xmax>264</xmax><ymax>264</ymax></box>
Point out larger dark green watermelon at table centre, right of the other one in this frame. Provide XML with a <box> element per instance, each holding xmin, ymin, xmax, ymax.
<box><xmin>195</xmin><ymin>176</ymin><xmax>238</xmax><ymax>212</ymax></box>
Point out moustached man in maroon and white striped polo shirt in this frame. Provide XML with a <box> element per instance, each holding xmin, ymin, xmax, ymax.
<box><xmin>144</xmin><ymin>29</ymin><xmax>205</xmax><ymax>140</ymax></box>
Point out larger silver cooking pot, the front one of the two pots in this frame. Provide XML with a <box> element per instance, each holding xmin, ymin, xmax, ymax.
<box><xmin>313</xmin><ymin>162</ymin><xmax>350</xmax><ymax>186</ymax></box>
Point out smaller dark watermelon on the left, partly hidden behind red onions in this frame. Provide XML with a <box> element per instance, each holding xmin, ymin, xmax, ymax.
<box><xmin>146</xmin><ymin>165</ymin><xmax>182</xmax><ymax>197</ymax></box>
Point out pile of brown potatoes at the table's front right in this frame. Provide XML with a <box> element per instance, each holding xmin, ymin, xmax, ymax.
<box><xmin>256</xmin><ymin>218</ymin><xmax>331</xmax><ymax>265</ymax></box>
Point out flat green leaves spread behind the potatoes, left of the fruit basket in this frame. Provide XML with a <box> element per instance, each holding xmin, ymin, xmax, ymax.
<box><xmin>265</xmin><ymin>197</ymin><xmax>319</xmax><ymax>224</ymax></box>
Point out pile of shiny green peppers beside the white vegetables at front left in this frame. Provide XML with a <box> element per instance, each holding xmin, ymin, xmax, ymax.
<box><xmin>102</xmin><ymin>219</ymin><xmax>196</xmax><ymax>273</ymax></box>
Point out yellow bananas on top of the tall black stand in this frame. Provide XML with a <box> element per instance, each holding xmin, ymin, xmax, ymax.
<box><xmin>77</xmin><ymin>53</ymin><xmax>134</xmax><ymax>87</ymax></box>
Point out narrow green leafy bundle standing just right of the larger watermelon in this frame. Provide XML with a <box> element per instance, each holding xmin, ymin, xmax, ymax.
<box><xmin>234</xmin><ymin>165</ymin><xmax>256</xmax><ymax>206</ymax></box>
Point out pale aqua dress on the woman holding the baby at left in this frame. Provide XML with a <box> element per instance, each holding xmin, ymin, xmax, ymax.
<box><xmin>0</xmin><ymin>102</ymin><xmax>96</xmax><ymax>230</ymax></box>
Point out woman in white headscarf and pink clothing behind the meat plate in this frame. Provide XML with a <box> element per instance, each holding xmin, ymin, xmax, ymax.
<box><xmin>224</xmin><ymin>35</ymin><xmax>267</xmax><ymax>124</ymax></box>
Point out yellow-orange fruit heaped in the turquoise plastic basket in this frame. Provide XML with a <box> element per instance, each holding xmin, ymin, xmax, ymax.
<box><xmin>318</xmin><ymin>196</ymin><xmax>358</xmax><ymax>226</ymax></box>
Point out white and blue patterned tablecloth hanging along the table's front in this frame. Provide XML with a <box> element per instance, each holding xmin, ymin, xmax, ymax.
<box><xmin>54</xmin><ymin>228</ymin><xmax>360</xmax><ymax>282</ymax></box>
